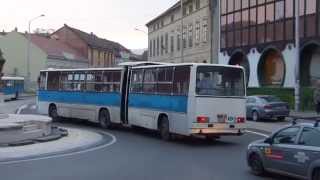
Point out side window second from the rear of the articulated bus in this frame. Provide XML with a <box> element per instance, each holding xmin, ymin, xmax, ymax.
<box><xmin>157</xmin><ymin>67</ymin><xmax>173</xmax><ymax>95</ymax></box>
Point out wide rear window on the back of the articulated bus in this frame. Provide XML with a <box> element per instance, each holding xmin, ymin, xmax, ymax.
<box><xmin>196</xmin><ymin>66</ymin><xmax>245</xmax><ymax>96</ymax></box>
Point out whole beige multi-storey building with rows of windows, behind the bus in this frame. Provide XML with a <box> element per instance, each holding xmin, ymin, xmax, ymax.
<box><xmin>146</xmin><ymin>0</ymin><xmax>219</xmax><ymax>63</ymax></box>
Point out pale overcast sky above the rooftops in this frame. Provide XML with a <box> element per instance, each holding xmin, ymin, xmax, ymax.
<box><xmin>0</xmin><ymin>0</ymin><xmax>178</xmax><ymax>49</ymax></box>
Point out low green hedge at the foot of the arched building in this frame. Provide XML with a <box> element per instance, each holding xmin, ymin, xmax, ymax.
<box><xmin>247</xmin><ymin>87</ymin><xmax>314</xmax><ymax>111</ymax></box>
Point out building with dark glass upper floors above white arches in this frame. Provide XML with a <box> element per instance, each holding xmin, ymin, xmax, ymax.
<box><xmin>219</xmin><ymin>0</ymin><xmax>320</xmax><ymax>88</ymax></box>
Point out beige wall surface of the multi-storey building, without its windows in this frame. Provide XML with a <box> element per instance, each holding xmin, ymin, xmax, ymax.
<box><xmin>148</xmin><ymin>0</ymin><xmax>217</xmax><ymax>63</ymax></box>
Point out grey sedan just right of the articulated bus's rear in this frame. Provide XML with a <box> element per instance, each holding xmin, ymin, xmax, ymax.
<box><xmin>246</xmin><ymin>95</ymin><xmax>290</xmax><ymax>121</ymax></box>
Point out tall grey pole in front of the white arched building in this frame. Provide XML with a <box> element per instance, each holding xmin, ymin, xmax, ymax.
<box><xmin>294</xmin><ymin>0</ymin><xmax>300</xmax><ymax>111</ymax></box>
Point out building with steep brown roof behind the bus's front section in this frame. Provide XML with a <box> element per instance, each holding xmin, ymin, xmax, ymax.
<box><xmin>51</xmin><ymin>24</ymin><xmax>130</xmax><ymax>67</ymax></box>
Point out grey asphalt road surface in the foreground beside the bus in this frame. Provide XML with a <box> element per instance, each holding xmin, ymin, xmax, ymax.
<box><xmin>0</xmin><ymin>98</ymin><xmax>296</xmax><ymax>180</ymax></box>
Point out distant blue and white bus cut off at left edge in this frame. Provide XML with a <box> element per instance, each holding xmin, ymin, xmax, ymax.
<box><xmin>0</xmin><ymin>76</ymin><xmax>24</xmax><ymax>100</ymax></box>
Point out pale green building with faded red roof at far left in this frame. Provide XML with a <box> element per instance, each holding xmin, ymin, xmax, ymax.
<box><xmin>0</xmin><ymin>31</ymin><xmax>88</xmax><ymax>91</ymax></box>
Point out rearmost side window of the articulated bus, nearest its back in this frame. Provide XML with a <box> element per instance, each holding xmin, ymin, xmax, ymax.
<box><xmin>173</xmin><ymin>66</ymin><xmax>190</xmax><ymax>96</ymax></box>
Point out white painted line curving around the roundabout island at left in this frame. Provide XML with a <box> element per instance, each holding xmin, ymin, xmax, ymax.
<box><xmin>0</xmin><ymin>131</ymin><xmax>117</xmax><ymax>165</ymax></box>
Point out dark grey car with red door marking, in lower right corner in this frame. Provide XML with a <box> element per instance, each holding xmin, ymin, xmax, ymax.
<box><xmin>247</xmin><ymin>121</ymin><xmax>320</xmax><ymax>180</ymax></box>
